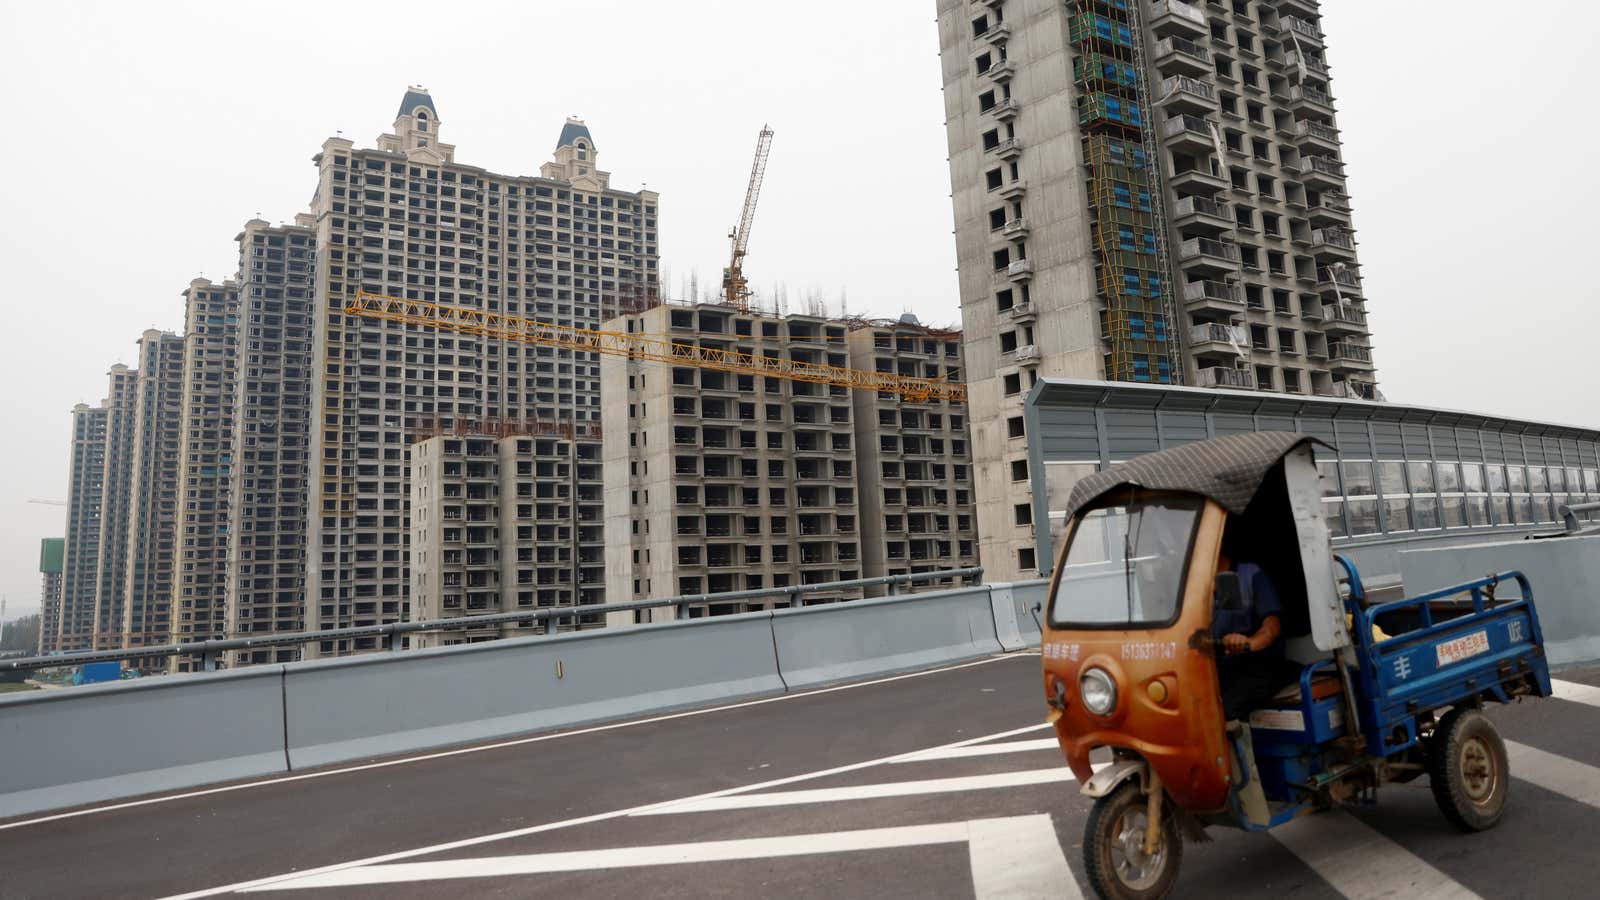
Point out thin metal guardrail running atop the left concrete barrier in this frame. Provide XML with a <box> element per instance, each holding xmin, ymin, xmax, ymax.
<box><xmin>0</xmin><ymin>565</ymin><xmax>984</xmax><ymax>673</ymax></box>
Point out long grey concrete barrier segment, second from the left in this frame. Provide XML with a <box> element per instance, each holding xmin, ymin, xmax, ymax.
<box><xmin>285</xmin><ymin>612</ymin><xmax>784</xmax><ymax>769</ymax></box>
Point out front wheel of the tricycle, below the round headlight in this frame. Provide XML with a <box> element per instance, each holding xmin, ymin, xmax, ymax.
<box><xmin>1083</xmin><ymin>778</ymin><xmax>1184</xmax><ymax>900</ymax></box>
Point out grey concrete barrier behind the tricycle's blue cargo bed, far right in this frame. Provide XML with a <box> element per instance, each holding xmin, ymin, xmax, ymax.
<box><xmin>1400</xmin><ymin>536</ymin><xmax>1600</xmax><ymax>665</ymax></box>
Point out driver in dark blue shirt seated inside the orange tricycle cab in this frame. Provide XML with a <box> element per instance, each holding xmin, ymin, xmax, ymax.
<box><xmin>1211</xmin><ymin>552</ymin><xmax>1283</xmax><ymax>721</ymax></box>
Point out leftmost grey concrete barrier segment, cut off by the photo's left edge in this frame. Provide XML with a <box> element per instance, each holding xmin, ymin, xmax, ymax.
<box><xmin>0</xmin><ymin>666</ymin><xmax>286</xmax><ymax>818</ymax></box>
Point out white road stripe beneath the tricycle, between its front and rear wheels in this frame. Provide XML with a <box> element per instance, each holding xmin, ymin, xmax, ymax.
<box><xmin>1269</xmin><ymin>812</ymin><xmax>1482</xmax><ymax>900</ymax></box>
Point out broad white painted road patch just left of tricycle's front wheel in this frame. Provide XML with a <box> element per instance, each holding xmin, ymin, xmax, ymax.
<box><xmin>966</xmin><ymin>815</ymin><xmax>1083</xmax><ymax>900</ymax></box>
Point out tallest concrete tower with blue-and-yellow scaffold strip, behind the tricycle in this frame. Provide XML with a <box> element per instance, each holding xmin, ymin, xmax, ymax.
<box><xmin>938</xmin><ymin>0</ymin><xmax>1376</xmax><ymax>581</ymax></box>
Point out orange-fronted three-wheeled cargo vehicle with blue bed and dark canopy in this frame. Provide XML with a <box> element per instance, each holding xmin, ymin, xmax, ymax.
<box><xmin>1042</xmin><ymin>432</ymin><xmax>1550</xmax><ymax>900</ymax></box>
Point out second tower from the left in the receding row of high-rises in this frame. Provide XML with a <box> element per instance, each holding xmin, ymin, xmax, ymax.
<box><xmin>93</xmin><ymin>362</ymin><xmax>139</xmax><ymax>650</ymax></box>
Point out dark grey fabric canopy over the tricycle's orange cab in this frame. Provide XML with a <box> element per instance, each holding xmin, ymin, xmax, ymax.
<box><xmin>1067</xmin><ymin>431</ymin><xmax>1326</xmax><ymax>517</ymax></box>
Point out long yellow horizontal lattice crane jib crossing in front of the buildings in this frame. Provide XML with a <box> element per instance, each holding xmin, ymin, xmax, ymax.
<box><xmin>344</xmin><ymin>291</ymin><xmax>966</xmax><ymax>404</ymax></box>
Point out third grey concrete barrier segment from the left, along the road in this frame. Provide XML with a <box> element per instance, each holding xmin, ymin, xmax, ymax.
<box><xmin>771</xmin><ymin>585</ymin><xmax>1003</xmax><ymax>690</ymax></box>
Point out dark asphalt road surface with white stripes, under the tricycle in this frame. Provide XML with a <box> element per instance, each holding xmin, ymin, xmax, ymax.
<box><xmin>0</xmin><ymin>653</ymin><xmax>1600</xmax><ymax>900</ymax></box>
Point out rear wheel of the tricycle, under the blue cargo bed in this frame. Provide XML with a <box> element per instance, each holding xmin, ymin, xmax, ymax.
<box><xmin>1427</xmin><ymin>708</ymin><xmax>1510</xmax><ymax>831</ymax></box>
